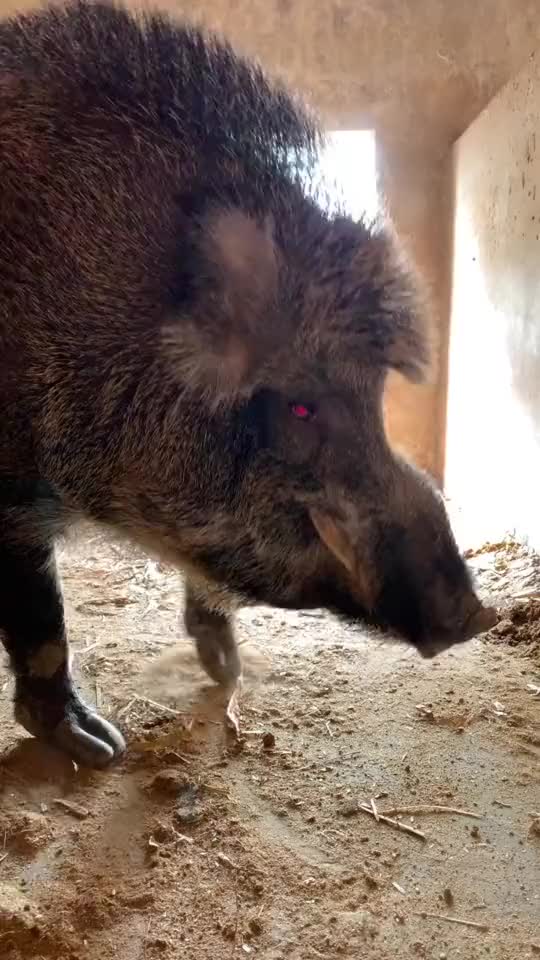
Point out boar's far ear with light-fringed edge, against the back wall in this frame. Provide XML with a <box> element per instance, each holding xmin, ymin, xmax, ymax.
<box><xmin>354</xmin><ymin>228</ymin><xmax>431</xmax><ymax>383</ymax></box>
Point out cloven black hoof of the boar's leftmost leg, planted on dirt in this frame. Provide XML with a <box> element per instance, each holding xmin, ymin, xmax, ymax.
<box><xmin>15</xmin><ymin>694</ymin><xmax>126</xmax><ymax>769</ymax></box>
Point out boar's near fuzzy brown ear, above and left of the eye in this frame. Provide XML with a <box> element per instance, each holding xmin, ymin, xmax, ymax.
<box><xmin>167</xmin><ymin>208</ymin><xmax>278</xmax><ymax>408</ymax></box>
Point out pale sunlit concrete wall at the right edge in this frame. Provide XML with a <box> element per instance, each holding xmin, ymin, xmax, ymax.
<box><xmin>446</xmin><ymin>54</ymin><xmax>540</xmax><ymax>548</ymax></box>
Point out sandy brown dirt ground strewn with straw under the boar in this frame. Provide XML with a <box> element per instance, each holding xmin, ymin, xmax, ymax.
<box><xmin>0</xmin><ymin>531</ymin><xmax>540</xmax><ymax>960</ymax></box>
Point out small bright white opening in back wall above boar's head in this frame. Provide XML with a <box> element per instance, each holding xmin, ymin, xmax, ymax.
<box><xmin>321</xmin><ymin>130</ymin><xmax>379</xmax><ymax>220</ymax></box>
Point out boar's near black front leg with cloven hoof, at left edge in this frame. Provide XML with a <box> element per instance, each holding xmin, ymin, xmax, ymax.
<box><xmin>0</xmin><ymin>528</ymin><xmax>125</xmax><ymax>767</ymax></box>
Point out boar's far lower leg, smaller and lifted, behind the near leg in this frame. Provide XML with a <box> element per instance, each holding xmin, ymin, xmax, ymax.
<box><xmin>184</xmin><ymin>583</ymin><xmax>242</xmax><ymax>687</ymax></box>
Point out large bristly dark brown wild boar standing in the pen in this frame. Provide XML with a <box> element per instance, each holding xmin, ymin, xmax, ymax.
<box><xmin>0</xmin><ymin>3</ymin><xmax>494</xmax><ymax>767</ymax></box>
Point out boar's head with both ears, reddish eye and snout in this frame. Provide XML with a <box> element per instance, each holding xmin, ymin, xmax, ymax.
<box><xmin>168</xmin><ymin>198</ymin><xmax>495</xmax><ymax>657</ymax></box>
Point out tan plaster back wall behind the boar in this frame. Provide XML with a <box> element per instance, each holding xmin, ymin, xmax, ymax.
<box><xmin>0</xmin><ymin>0</ymin><xmax>540</xmax><ymax>478</ymax></box>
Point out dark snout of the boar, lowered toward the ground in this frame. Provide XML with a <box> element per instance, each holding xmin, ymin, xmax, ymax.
<box><xmin>310</xmin><ymin>474</ymin><xmax>498</xmax><ymax>659</ymax></box>
